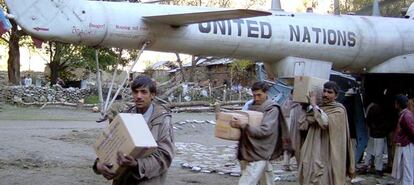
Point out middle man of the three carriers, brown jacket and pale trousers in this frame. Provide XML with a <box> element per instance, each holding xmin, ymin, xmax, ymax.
<box><xmin>230</xmin><ymin>82</ymin><xmax>290</xmax><ymax>185</ymax></box>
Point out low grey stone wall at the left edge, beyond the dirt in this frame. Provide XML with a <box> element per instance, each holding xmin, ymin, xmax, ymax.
<box><xmin>3</xmin><ymin>85</ymin><xmax>90</xmax><ymax>103</ymax></box>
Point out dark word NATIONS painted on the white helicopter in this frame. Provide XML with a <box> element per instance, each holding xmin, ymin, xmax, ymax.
<box><xmin>289</xmin><ymin>25</ymin><xmax>357</xmax><ymax>47</ymax></box>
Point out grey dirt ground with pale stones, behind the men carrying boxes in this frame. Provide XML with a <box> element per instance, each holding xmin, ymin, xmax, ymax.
<box><xmin>0</xmin><ymin>105</ymin><xmax>394</xmax><ymax>185</ymax></box>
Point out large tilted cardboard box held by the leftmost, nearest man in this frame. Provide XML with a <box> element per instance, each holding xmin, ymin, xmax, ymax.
<box><xmin>93</xmin><ymin>113</ymin><xmax>158</xmax><ymax>174</ymax></box>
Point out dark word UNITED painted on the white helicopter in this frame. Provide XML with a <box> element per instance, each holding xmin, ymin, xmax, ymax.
<box><xmin>198</xmin><ymin>19</ymin><xmax>272</xmax><ymax>39</ymax></box>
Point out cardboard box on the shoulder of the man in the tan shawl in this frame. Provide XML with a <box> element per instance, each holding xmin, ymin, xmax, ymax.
<box><xmin>293</xmin><ymin>76</ymin><xmax>328</xmax><ymax>103</ymax></box>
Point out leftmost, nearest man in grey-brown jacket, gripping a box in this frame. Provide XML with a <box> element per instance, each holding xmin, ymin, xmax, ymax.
<box><xmin>94</xmin><ymin>76</ymin><xmax>175</xmax><ymax>185</ymax></box>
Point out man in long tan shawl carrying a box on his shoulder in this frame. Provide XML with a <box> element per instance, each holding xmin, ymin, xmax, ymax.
<box><xmin>299</xmin><ymin>82</ymin><xmax>355</xmax><ymax>185</ymax></box>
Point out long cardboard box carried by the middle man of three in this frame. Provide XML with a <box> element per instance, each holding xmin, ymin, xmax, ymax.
<box><xmin>214</xmin><ymin>111</ymin><xmax>263</xmax><ymax>141</ymax></box>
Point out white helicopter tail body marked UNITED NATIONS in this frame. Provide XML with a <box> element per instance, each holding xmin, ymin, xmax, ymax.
<box><xmin>6</xmin><ymin>0</ymin><xmax>414</xmax><ymax>71</ymax></box>
